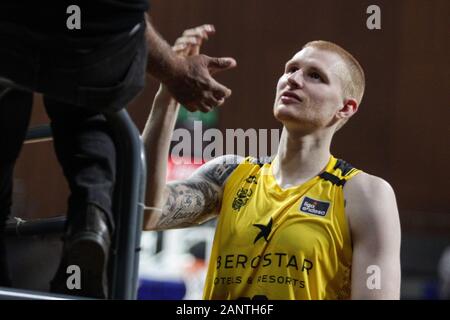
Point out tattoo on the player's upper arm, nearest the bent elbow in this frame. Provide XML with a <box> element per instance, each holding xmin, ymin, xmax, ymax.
<box><xmin>158</xmin><ymin>179</ymin><xmax>220</xmax><ymax>229</ymax></box>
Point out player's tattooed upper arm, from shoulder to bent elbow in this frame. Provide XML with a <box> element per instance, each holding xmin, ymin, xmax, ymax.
<box><xmin>145</xmin><ymin>155</ymin><xmax>243</xmax><ymax>230</ymax></box>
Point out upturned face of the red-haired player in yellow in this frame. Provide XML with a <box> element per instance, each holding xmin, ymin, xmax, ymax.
<box><xmin>274</xmin><ymin>47</ymin><xmax>346</xmax><ymax>132</ymax></box>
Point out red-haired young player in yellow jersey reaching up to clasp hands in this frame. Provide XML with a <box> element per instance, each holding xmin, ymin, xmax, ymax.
<box><xmin>143</xmin><ymin>27</ymin><xmax>400</xmax><ymax>299</ymax></box>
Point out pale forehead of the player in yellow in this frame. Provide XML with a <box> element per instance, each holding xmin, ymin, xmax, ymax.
<box><xmin>288</xmin><ymin>47</ymin><xmax>346</xmax><ymax>80</ymax></box>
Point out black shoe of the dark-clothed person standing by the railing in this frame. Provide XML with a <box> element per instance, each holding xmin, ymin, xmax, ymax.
<box><xmin>50</xmin><ymin>205</ymin><xmax>111</xmax><ymax>299</ymax></box>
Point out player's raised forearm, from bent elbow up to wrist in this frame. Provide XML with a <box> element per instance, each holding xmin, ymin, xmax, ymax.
<box><xmin>142</xmin><ymin>87</ymin><xmax>179</xmax><ymax>225</ymax></box>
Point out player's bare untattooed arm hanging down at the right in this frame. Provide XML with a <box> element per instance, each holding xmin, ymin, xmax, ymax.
<box><xmin>344</xmin><ymin>173</ymin><xmax>401</xmax><ymax>299</ymax></box>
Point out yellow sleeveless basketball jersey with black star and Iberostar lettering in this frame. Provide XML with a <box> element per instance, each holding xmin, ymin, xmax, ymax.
<box><xmin>203</xmin><ymin>156</ymin><xmax>361</xmax><ymax>300</ymax></box>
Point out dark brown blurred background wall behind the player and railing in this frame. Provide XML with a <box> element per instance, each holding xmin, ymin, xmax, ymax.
<box><xmin>13</xmin><ymin>0</ymin><xmax>450</xmax><ymax>299</ymax></box>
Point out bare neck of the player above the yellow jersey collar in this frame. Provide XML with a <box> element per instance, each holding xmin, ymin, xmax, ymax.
<box><xmin>273</xmin><ymin>128</ymin><xmax>332</xmax><ymax>188</ymax></box>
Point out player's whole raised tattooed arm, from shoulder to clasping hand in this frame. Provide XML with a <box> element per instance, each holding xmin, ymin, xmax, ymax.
<box><xmin>142</xmin><ymin>25</ymin><xmax>241</xmax><ymax>230</ymax></box>
